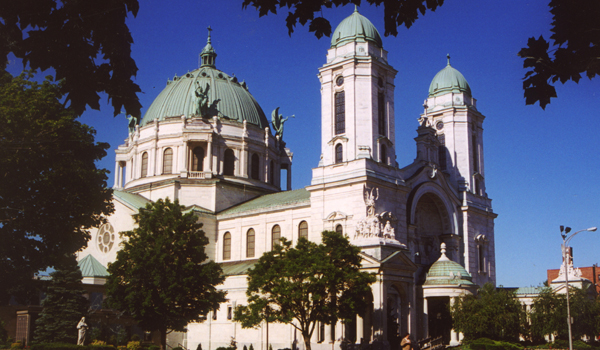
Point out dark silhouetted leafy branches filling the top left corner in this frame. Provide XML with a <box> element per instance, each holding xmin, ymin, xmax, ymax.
<box><xmin>0</xmin><ymin>0</ymin><xmax>141</xmax><ymax>117</ymax></box>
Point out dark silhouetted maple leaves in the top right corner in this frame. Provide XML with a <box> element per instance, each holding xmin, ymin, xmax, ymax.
<box><xmin>519</xmin><ymin>0</ymin><xmax>600</xmax><ymax>109</ymax></box>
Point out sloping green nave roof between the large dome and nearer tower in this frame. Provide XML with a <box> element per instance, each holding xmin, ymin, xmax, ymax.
<box><xmin>219</xmin><ymin>188</ymin><xmax>310</xmax><ymax>215</ymax></box>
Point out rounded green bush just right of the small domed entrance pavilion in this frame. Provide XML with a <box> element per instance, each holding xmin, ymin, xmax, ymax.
<box><xmin>450</xmin><ymin>283</ymin><xmax>527</xmax><ymax>341</ymax></box>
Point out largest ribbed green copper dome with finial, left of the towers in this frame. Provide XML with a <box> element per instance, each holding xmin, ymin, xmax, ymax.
<box><xmin>140</xmin><ymin>31</ymin><xmax>269</xmax><ymax>129</ymax></box>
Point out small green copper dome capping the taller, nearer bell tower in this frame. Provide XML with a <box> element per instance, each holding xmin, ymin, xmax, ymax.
<box><xmin>331</xmin><ymin>7</ymin><xmax>383</xmax><ymax>47</ymax></box>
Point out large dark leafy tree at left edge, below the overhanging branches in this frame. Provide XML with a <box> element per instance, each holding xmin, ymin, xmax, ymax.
<box><xmin>0</xmin><ymin>71</ymin><xmax>113</xmax><ymax>303</ymax></box>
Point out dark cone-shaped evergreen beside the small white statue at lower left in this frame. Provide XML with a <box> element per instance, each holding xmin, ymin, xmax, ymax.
<box><xmin>34</xmin><ymin>255</ymin><xmax>89</xmax><ymax>344</ymax></box>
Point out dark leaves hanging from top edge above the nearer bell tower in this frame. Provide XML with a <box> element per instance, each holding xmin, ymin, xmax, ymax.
<box><xmin>242</xmin><ymin>0</ymin><xmax>444</xmax><ymax>39</ymax></box>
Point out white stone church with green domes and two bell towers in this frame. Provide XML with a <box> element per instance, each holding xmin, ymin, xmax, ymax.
<box><xmin>79</xmin><ymin>10</ymin><xmax>496</xmax><ymax>350</ymax></box>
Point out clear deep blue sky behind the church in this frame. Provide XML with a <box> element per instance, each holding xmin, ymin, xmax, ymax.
<box><xmin>9</xmin><ymin>0</ymin><xmax>600</xmax><ymax>287</ymax></box>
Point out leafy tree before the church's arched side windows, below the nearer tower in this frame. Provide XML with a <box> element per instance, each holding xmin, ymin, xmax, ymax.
<box><xmin>234</xmin><ymin>231</ymin><xmax>375</xmax><ymax>350</ymax></box>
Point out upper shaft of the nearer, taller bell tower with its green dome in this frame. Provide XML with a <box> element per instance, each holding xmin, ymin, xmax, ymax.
<box><xmin>319</xmin><ymin>9</ymin><xmax>397</xmax><ymax>166</ymax></box>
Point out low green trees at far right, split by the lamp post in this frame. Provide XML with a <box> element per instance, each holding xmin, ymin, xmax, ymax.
<box><xmin>529</xmin><ymin>288</ymin><xmax>600</xmax><ymax>340</ymax></box>
